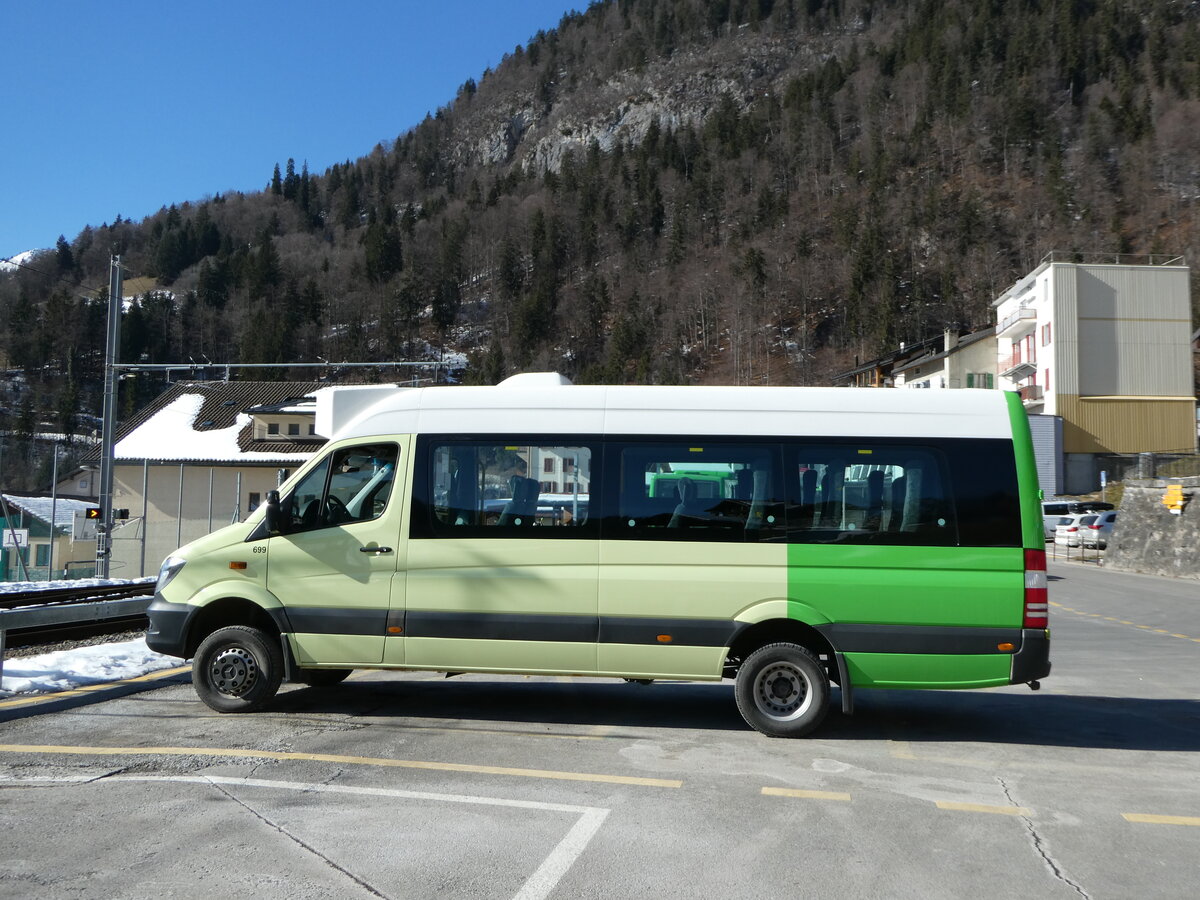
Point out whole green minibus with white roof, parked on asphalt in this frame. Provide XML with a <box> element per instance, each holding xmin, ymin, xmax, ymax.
<box><xmin>146</xmin><ymin>373</ymin><xmax>1050</xmax><ymax>737</ymax></box>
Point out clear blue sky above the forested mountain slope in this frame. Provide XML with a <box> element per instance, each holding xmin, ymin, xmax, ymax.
<box><xmin>0</xmin><ymin>0</ymin><xmax>587</xmax><ymax>258</ymax></box>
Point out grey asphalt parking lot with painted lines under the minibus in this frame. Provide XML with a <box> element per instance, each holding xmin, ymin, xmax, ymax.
<box><xmin>0</xmin><ymin>563</ymin><xmax>1200</xmax><ymax>898</ymax></box>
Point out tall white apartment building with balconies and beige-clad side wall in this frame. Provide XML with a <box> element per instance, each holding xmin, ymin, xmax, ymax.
<box><xmin>992</xmin><ymin>253</ymin><xmax>1196</xmax><ymax>493</ymax></box>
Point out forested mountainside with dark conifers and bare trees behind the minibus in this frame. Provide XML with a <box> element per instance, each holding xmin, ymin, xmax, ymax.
<box><xmin>0</xmin><ymin>0</ymin><xmax>1200</xmax><ymax>494</ymax></box>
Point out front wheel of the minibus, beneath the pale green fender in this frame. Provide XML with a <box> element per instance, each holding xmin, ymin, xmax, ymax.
<box><xmin>192</xmin><ymin>625</ymin><xmax>283</xmax><ymax>713</ymax></box>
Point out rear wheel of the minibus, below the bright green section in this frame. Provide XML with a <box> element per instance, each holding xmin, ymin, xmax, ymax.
<box><xmin>733</xmin><ymin>643</ymin><xmax>829</xmax><ymax>738</ymax></box>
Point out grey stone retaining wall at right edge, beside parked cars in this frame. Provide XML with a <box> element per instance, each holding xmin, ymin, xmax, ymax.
<box><xmin>1104</xmin><ymin>478</ymin><xmax>1200</xmax><ymax>580</ymax></box>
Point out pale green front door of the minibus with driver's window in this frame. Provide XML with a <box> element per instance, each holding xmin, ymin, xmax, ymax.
<box><xmin>266</xmin><ymin>442</ymin><xmax>404</xmax><ymax>666</ymax></box>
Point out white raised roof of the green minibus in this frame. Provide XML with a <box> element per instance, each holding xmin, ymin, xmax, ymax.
<box><xmin>317</xmin><ymin>372</ymin><xmax>1012</xmax><ymax>439</ymax></box>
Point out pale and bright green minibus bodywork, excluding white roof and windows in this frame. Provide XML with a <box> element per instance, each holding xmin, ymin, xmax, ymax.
<box><xmin>148</xmin><ymin>376</ymin><xmax>1049</xmax><ymax>727</ymax></box>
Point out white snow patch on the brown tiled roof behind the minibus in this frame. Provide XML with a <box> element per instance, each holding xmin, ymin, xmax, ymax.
<box><xmin>113</xmin><ymin>392</ymin><xmax>312</xmax><ymax>464</ymax></box>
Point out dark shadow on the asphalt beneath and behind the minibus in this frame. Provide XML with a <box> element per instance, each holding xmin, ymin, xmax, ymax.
<box><xmin>270</xmin><ymin>676</ymin><xmax>1200</xmax><ymax>751</ymax></box>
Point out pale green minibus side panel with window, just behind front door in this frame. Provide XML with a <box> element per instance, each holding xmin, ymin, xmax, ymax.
<box><xmin>404</xmin><ymin>437</ymin><xmax>599</xmax><ymax>672</ymax></box>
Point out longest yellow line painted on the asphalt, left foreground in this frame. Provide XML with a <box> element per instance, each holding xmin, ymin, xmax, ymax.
<box><xmin>0</xmin><ymin>744</ymin><xmax>683</xmax><ymax>787</ymax></box>
